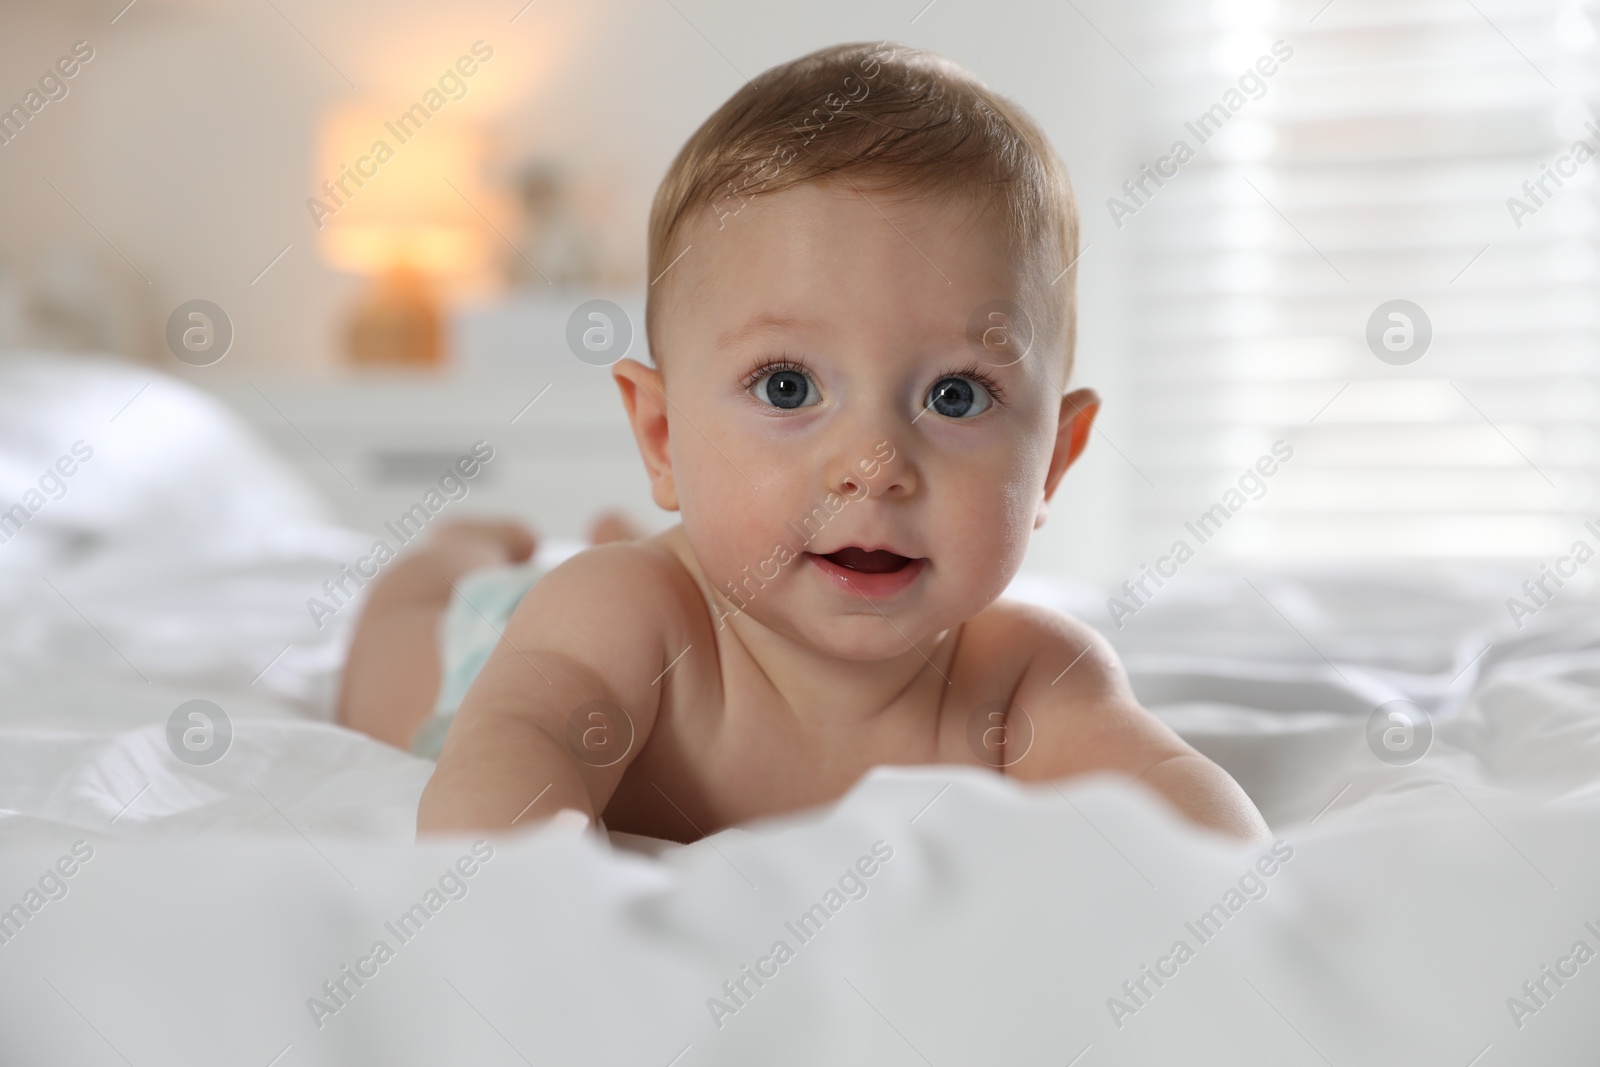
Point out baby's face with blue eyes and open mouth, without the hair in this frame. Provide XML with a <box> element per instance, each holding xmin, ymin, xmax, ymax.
<box><xmin>618</xmin><ymin>182</ymin><xmax>1093</xmax><ymax>659</ymax></box>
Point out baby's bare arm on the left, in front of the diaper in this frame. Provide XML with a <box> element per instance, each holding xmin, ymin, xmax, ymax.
<box><xmin>418</xmin><ymin>544</ymin><xmax>685</xmax><ymax>833</ymax></box>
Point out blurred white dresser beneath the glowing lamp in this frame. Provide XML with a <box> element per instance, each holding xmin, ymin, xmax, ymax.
<box><xmin>202</xmin><ymin>293</ymin><xmax>674</xmax><ymax>539</ymax></box>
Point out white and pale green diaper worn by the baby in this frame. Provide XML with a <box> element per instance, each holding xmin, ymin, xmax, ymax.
<box><xmin>411</xmin><ymin>563</ymin><xmax>546</xmax><ymax>760</ymax></box>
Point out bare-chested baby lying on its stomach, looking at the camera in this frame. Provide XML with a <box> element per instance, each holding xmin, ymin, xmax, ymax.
<box><xmin>347</xmin><ymin>45</ymin><xmax>1267</xmax><ymax>841</ymax></box>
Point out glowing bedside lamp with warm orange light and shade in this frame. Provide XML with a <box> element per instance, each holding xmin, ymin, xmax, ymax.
<box><xmin>307</xmin><ymin>102</ymin><xmax>490</xmax><ymax>366</ymax></box>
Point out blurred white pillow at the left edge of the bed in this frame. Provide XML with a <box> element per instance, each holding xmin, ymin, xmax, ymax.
<box><xmin>0</xmin><ymin>352</ymin><xmax>333</xmax><ymax>569</ymax></box>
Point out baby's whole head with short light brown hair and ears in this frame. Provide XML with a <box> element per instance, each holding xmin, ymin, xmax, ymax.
<box><xmin>614</xmin><ymin>45</ymin><xmax>1098</xmax><ymax>659</ymax></box>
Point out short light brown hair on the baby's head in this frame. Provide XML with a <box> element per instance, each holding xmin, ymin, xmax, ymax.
<box><xmin>645</xmin><ymin>43</ymin><xmax>1078</xmax><ymax>374</ymax></box>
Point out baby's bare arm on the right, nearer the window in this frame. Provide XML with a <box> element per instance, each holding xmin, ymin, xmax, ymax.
<box><xmin>1006</xmin><ymin>606</ymin><xmax>1270</xmax><ymax>840</ymax></box>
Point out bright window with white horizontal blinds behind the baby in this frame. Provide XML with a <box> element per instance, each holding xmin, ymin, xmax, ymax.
<box><xmin>1126</xmin><ymin>0</ymin><xmax>1600</xmax><ymax>560</ymax></box>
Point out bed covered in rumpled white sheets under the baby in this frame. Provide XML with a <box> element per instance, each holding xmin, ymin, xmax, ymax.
<box><xmin>0</xmin><ymin>354</ymin><xmax>1600</xmax><ymax>1067</ymax></box>
